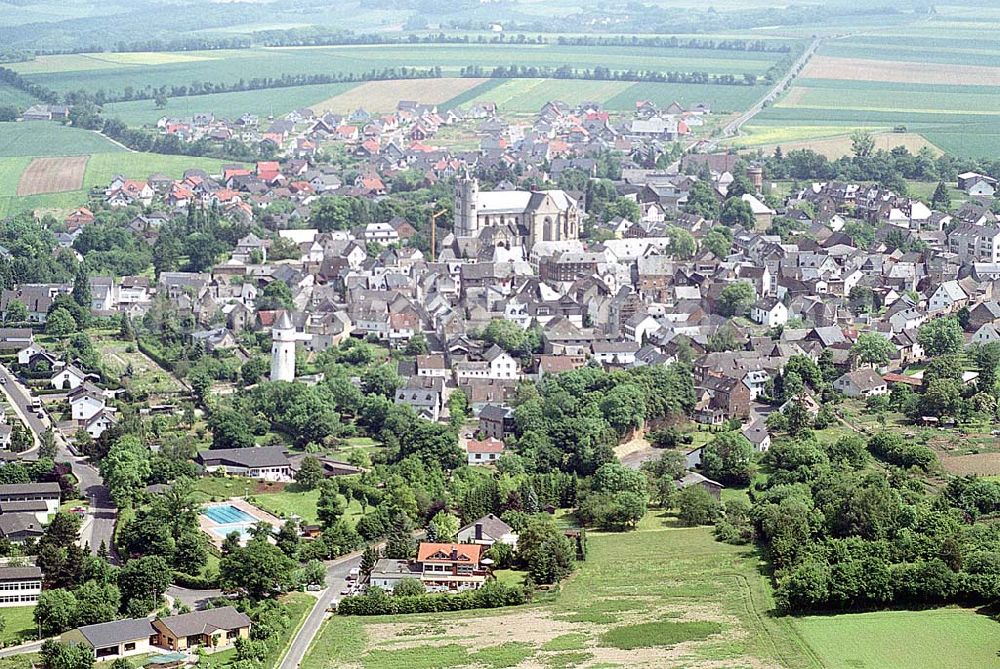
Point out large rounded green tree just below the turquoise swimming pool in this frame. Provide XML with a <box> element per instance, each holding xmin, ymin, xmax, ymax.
<box><xmin>219</xmin><ymin>539</ymin><xmax>296</xmax><ymax>599</ymax></box>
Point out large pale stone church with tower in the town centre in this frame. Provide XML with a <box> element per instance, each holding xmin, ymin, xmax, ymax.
<box><xmin>455</xmin><ymin>176</ymin><xmax>580</xmax><ymax>255</ymax></box>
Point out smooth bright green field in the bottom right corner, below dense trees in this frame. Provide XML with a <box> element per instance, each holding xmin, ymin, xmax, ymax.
<box><xmin>794</xmin><ymin>608</ymin><xmax>1000</xmax><ymax>669</ymax></box>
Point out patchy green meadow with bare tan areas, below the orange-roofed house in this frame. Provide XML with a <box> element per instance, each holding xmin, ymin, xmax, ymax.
<box><xmin>302</xmin><ymin>514</ymin><xmax>820</xmax><ymax>669</ymax></box>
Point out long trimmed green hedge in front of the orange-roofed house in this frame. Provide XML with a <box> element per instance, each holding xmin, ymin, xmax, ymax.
<box><xmin>337</xmin><ymin>581</ymin><xmax>528</xmax><ymax>616</ymax></box>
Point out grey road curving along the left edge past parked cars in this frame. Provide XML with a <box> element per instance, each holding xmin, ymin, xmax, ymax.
<box><xmin>0</xmin><ymin>365</ymin><xmax>118</xmax><ymax>553</ymax></box>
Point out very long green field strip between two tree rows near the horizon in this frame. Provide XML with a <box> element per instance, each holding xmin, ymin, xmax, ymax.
<box><xmin>11</xmin><ymin>44</ymin><xmax>780</xmax><ymax>98</ymax></box>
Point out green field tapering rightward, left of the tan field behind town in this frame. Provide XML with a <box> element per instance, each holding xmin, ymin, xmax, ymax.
<box><xmin>104</xmin><ymin>83</ymin><xmax>357</xmax><ymax>126</ymax></box>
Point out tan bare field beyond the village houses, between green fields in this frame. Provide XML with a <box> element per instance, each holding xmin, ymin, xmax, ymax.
<box><xmin>311</xmin><ymin>78</ymin><xmax>485</xmax><ymax>114</ymax></box>
